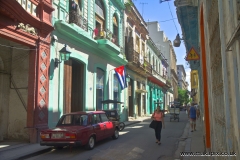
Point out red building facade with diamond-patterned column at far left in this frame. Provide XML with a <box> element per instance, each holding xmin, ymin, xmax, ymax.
<box><xmin>0</xmin><ymin>0</ymin><xmax>54</xmax><ymax>142</ymax></box>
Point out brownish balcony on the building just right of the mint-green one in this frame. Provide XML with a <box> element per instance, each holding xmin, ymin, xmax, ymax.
<box><xmin>126</xmin><ymin>49</ymin><xmax>152</xmax><ymax>77</ymax></box>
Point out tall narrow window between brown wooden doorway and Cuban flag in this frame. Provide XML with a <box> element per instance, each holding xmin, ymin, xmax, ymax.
<box><xmin>96</xmin><ymin>68</ymin><xmax>104</xmax><ymax>110</ymax></box>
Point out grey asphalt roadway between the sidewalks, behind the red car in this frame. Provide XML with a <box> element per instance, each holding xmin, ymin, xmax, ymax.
<box><xmin>27</xmin><ymin>111</ymin><xmax>188</xmax><ymax>160</ymax></box>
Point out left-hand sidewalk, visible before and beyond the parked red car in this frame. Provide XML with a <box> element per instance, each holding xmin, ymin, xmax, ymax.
<box><xmin>0</xmin><ymin>116</ymin><xmax>150</xmax><ymax>160</ymax></box>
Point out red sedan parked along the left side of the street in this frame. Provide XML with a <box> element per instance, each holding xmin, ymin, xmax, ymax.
<box><xmin>40</xmin><ymin>111</ymin><xmax>119</xmax><ymax>149</ymax></box>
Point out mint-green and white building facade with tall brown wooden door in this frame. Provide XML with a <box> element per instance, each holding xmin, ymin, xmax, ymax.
<box><xmin>48</xmin><ymin>0</ymin><xmax>127</xmax><ymax>127</ymax></box>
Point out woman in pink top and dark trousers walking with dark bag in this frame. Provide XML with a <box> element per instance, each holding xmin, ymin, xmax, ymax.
<box><xmin>152</xmin><ymin>106</ymin><xmax>165</xmax><ymax>145</ymax></box>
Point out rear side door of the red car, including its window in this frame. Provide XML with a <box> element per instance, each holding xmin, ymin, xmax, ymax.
<box><xmin>92</xmin><ymin>114</ymin><xmax>105</xmax><ymax>141</ymax></box>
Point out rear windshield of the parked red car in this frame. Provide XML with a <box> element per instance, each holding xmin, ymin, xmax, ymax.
<box><xmin>57</xmin><ymin>114</ymin><xmax>88</xmax><ymax>126</ymax></box>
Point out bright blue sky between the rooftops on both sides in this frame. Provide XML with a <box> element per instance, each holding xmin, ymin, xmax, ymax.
<box><xmin>132</xmin><ymin>0</ymin><xmax>191</xmax><ymax>90</ymax></box>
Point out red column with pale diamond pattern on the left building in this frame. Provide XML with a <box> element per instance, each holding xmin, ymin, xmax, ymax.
<box><xmin>27</xmin><ymin>43</ymin><xmax>50</xmax><ymax>143</ymax></box>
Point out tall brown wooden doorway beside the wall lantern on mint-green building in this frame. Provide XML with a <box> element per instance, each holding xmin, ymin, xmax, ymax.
<box><xmin>63</xmin><ymin>58</ymin><xmax>84</xmax><ymax>113</ymax></box>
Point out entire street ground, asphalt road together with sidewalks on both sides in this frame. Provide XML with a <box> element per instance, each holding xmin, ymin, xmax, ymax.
<box><xmin>0</xmin><ymin>112</ymin><xmax>203</xmax><ymax>160</ymax></box>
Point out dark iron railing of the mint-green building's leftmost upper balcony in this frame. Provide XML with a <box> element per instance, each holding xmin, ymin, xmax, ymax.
<box><xmin>69</xmin><ymin>11</ymin><xmax>88</xmax><ymax>31</ymax></box>
